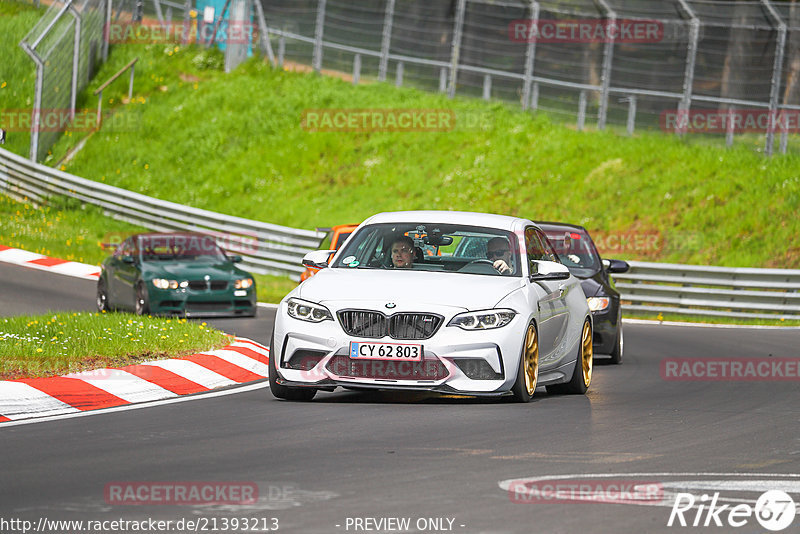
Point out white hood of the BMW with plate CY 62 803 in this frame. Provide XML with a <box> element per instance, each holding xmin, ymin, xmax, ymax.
<box><xmin>296</xmin><ymin>268</ymin><xmax>524</xmax><ymax>311</ymax></box>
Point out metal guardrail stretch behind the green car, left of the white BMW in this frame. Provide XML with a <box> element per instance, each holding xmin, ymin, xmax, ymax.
<box><xmin>0</xmin><ymin>149</ymin><xmax>325</xmax><ymax>280</ymax></box>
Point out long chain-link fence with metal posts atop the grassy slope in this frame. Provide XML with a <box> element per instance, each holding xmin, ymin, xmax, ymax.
<box><xmin>261</xmin><ymin>0</ymin><xmax>800</xmax><ymax>154</ymax></box>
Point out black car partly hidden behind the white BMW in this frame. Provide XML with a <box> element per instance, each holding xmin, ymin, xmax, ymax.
<box><xmin>536</xmin><ymin>222</ymin><xmax>630</xmax><ymax>363</ymax></box>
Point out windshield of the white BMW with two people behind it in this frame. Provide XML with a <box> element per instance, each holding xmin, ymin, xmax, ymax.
<box><xmin>331</xmin><ymin>222</ymin><xmax>521</xmax><ymax>276</ymax></box>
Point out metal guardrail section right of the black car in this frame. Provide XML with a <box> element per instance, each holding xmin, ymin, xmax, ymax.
<box><xmin>614</xmin><ymin>261</ymin><xmax>800</xmax><ymax>319</ymax></box>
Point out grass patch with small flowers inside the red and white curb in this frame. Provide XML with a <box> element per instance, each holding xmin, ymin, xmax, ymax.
<box><xmin>0</xmin><ymin>312</ymin><xmax>230</xmax><ymax>380</ymax></box>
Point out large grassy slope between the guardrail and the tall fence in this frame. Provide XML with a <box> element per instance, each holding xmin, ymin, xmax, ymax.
<box><xmin>39</xmin><ymin>45</ymin><xmax>800</xmax><ymax>268</ymax></box>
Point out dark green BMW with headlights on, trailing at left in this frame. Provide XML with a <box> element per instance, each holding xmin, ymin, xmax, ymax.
<box><xmin>97</xmin><ymin>232</ymin><xmax>256</xmax><ymax>317</ymax></box>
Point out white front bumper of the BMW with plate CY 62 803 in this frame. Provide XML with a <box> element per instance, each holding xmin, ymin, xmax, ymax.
<box><xmin>273</xmin><ymin>312</ymin><xmax>523</xmax><ymax>395</ymax></box>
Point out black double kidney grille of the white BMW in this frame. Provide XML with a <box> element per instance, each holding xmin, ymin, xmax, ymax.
<box><xmin>337</xmin><ymin>310</ymin><xmax>444</xmax><ymax>339</ymax></box>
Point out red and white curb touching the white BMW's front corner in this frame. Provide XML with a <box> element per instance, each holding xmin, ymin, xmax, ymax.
<box><xmin>0</xmin><ymin>338</ymin><xmax>269</xmax><ymax>422</ymax></box>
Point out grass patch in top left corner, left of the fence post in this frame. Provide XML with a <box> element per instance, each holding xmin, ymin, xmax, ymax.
<box><xmin>0</xmin><ymin>0</ymin><xmax>44</xmax><ymax>157</ymax></box>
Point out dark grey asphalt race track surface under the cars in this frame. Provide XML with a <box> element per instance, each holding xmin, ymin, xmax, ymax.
<box><xmin>0</xmin><ymin>264</ymin><xmax>800</xmax><ymax>533</ymax></box>
